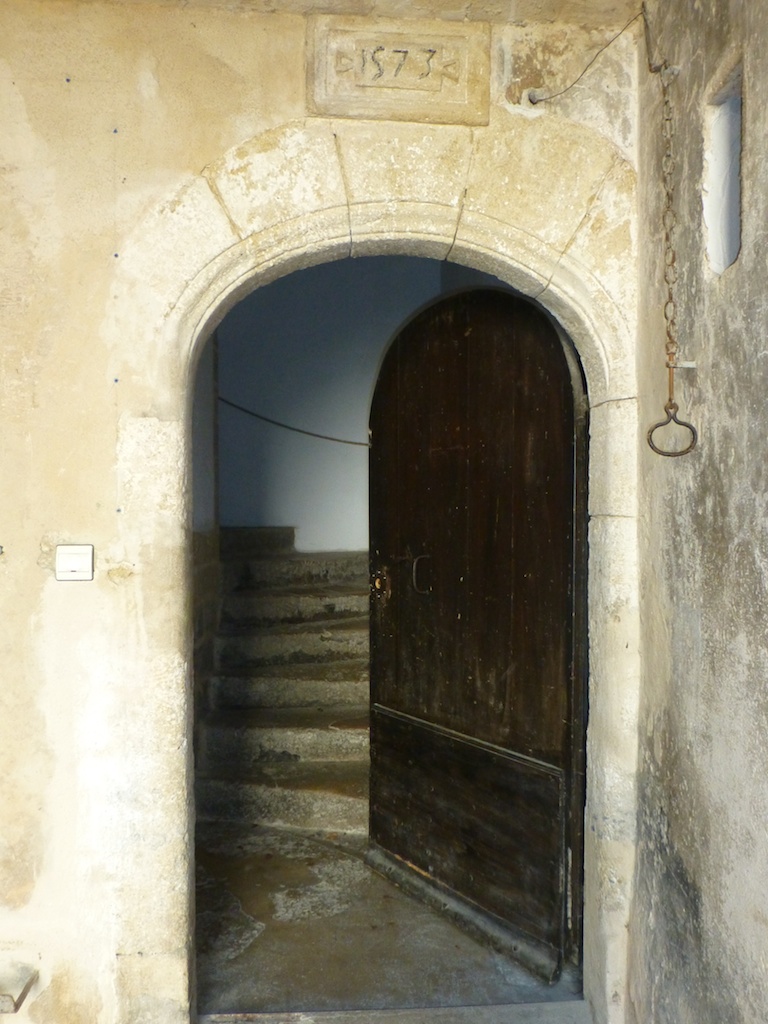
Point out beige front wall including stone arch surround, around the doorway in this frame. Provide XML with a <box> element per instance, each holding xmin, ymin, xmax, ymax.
<box><xmin>0</xmin><ymin>0</ymin><xmax>651</xmax><ymax>1024</ymax></box>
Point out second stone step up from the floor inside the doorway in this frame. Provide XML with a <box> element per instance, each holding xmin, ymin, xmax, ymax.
<box><xmin>198</xmin><ymin>707</ymin><xmax>369</xmax><ymax>778</ymax></box>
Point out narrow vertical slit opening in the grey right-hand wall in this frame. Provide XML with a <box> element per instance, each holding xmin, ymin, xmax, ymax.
<box><xmin>701</xmin><ymin>68</ymin><xmax>741</xmax><ymax>273</ymax></box>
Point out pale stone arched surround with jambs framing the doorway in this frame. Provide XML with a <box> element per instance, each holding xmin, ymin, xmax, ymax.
<box><xmin>104</xmin><ymin>113</ymin><xmax>640</xmax><ymax>1024</ymax></box>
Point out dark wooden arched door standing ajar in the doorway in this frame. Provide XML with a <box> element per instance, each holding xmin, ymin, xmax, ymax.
<box><xmin>370</xmin><ymin>290</ymin><xmax>586</xmax><ymax>977</ymax></box>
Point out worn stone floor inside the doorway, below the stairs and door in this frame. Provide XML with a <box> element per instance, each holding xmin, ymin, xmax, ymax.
<box><xmin>197</xmin><ymin>822</ymin><xmax>588</xmax><ymax>1024</ymax></box>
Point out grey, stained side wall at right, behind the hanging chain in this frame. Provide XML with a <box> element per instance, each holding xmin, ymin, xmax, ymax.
<box><xmin>631</xmin><ymin>0</ymin><xmax>768</xmax><ymax>1024</ymax></box>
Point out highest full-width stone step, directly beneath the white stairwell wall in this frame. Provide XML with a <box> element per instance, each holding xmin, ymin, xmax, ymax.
<box><xmin>221</xmin><ymin>551</ymin><xmax>369</xmax><ymax>594</ymax></box>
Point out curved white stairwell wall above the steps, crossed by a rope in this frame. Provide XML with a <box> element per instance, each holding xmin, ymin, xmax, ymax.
<box><xmin>218</xmin><ymin>256</ymin><xmax>499</xmax><ymax>551</ymax></box>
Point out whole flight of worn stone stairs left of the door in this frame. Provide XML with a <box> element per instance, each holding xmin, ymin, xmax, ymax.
<box><xmin>196</xmin><ymin>528</ymin><xmax>369</xmax><ymax>831</ymax></box>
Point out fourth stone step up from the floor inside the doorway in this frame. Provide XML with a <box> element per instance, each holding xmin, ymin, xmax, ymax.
<box><xmin>214</xmin><ymin>616</ymin><xmax>369</xmax><ymax>670</ymax></box>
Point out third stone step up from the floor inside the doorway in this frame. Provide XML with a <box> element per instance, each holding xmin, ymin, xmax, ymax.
<box><xmin>208</xmin><ymin>657</ymin><xmax>369</xmax><ymax>710</ymax></box>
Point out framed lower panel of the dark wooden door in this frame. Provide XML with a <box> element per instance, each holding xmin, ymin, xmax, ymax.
<box><xmin>371</xmin><ymin>707</ymin><xmax>564</xmax><ymax>950</ymax></box>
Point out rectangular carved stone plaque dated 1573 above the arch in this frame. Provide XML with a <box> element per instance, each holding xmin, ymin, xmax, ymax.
<box><xmin>307</xmin><ymin>15</ymin><xmax>490</xmax><ymax>125</ymax></box>
